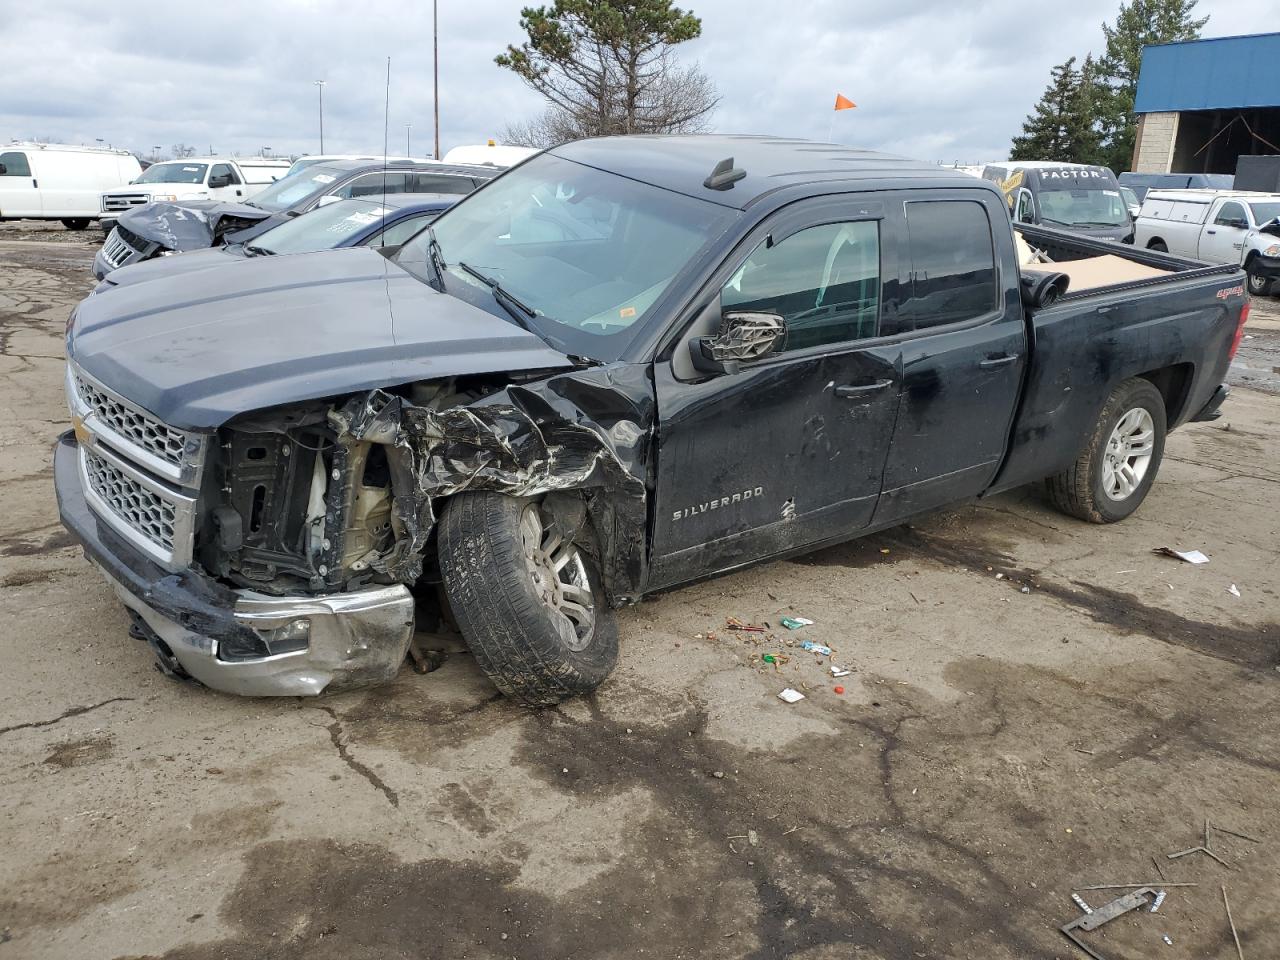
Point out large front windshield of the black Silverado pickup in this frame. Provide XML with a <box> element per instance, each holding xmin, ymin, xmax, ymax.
<box><xmin>396</xmin><ymin>154</ymin><xmax>735</xmax><ymax>360</ymax></box>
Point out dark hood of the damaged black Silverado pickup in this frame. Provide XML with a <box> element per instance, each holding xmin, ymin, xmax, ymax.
<box><xmin>67</xmin><ymin>247</ymin><xmax>573</xmax><ymax>429</ymax></box>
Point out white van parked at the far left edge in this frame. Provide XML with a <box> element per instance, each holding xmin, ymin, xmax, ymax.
<box><xmin>0</xmin><ymin>143</ymin><xmax>142</xmax><ymax>230</ymax></box>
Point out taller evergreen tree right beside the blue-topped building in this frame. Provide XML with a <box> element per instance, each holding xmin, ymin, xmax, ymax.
<box><xmin>1096</xmin><ymin>0</ymin><xmax>1208</xmax><ymax>173</ymax></box>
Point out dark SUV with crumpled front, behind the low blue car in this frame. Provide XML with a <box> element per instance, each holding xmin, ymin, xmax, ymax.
<box><xmin>93</xmin><ymin>160</ymin><xmax>495</xmax><ymax>280</ymax></box>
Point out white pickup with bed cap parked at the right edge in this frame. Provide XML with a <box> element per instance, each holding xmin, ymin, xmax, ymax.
<box><xmin>1134</xmin><ymin>189</ymin><xmax>1280</xmax><ymax>297</ymax></box>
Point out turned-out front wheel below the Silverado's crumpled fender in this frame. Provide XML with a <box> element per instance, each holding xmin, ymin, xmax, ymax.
<box><xmin>438</xmin><ymin>492</ymin><xmax>618</xmax><ymax>707</ymax></box>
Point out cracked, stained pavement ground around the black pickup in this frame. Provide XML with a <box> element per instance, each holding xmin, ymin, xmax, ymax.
<box><xmin>0</xmin><ymin>225</ymin><xmax>1280</xmax><ymax>960</ymax></box>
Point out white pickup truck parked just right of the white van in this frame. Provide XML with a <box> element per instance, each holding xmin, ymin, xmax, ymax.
<box><xmin>101</xmin><ymin>156</ymin><xmax>289</xmax><ymax>233</ymax></box>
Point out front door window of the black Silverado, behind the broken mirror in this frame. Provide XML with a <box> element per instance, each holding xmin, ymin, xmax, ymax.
<box><xmin>721</xmin><ymin>220</ymin><xmax>881</xmax><ymax>352</ymax></box>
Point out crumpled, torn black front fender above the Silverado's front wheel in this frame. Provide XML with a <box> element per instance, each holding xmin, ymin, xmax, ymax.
<box><xmin>330</xmin><ymin>365</ymin><xmax>653</xmax><ymax>604</ymax></box>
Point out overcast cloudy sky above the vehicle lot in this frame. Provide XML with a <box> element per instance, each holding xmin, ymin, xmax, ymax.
<box><xmin>0</xmin><ymin>0</ymin><xmax>1257</xmax><ymax>163</ymax></box>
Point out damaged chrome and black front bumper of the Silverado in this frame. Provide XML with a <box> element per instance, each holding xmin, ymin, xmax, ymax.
<box><xmin>54</xmin><ymin>433</ymin><xmax>413</xmax><ymax>696</ymax></box>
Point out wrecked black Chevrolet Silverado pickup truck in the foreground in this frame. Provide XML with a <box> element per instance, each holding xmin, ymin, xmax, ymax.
<box><xmin>55</xmin><ymin>137</ymin><xmax>1248</xmax><ymax>704</ymax></box>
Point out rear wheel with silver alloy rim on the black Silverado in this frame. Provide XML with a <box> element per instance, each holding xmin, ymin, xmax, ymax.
<box><xmin>1046</xmin><ymin>378</ymin><xmax>1167</xmax><ymax>524</ymax></box>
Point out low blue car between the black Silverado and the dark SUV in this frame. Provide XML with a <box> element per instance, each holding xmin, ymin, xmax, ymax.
<box><xmin>93</xmin><ymin>193</ymin><xmax>450</xmax><ymax>293</ymax></box>
